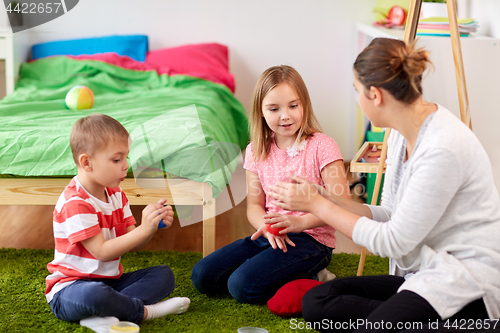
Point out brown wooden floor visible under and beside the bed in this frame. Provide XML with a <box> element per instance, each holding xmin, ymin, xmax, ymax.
<box><xmin>0</xmin><ymin>162</ymin><xmax>361</xmax><ymax>253</ymax></box>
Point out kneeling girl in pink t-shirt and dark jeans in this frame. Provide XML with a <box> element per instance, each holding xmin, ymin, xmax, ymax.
<box><xmin>191</xmin><ymin>66</ymin><xmax>350</xmax><ymax>304</ymax></box>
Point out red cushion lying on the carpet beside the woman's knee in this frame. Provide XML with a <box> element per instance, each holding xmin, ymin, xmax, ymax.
<box><xmin>267</xmin><ymin>279</ymin><xmax>323</xmax><ymax>317</ymax></box>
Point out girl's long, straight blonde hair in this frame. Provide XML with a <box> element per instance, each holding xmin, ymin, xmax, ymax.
<box><xmin>250</xmin><ymin>65</ymin><xmax>323</xmax><ymax>161</ymax></box>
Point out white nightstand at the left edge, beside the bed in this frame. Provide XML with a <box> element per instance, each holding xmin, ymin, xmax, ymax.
<box><xmin>0</xmin><ymin>27</ymin><xmax>30</xmax><ymax>98</ymax></box>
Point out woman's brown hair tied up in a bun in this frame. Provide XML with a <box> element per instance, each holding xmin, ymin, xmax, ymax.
<box><xmin>354</xmin><ymin>38</ymin><xmax>432</xmax><ymax>104</ymax></box>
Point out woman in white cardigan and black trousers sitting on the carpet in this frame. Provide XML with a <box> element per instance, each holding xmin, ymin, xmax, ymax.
<box><xmin>271</xmin><ymin>38</ymin><xmax>500</xmax><ymax>331</ymax></box>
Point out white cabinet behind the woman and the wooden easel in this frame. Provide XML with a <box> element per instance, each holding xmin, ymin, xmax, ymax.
<box><xmin>356</xmin><ymin>23</ymin><xmax>500</xmax><ymax>190</ymax></box>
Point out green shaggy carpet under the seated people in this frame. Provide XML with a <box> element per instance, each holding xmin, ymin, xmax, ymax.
<box><xmin>0</xmin><ymin>248</ymin><xmax>388</xmax><ymax>333</ymax></box>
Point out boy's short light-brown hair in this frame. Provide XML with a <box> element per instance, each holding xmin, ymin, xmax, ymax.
<box><xmin>69</xmin><ymin>113</ymin><xmax>129</xmax><ymax>166</ymax></box>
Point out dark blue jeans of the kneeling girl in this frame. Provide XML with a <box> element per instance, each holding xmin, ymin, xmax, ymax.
<box><xmin>191</xmin><ymin>232</ymin><xmax>332</xmax><ymax>304</ymax></box>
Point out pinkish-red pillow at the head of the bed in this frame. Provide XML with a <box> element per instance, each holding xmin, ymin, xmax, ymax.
<box><xmin>146</xmin><ymin>43</ymin><xmax>234</xmax><ymax>92</ymax></box>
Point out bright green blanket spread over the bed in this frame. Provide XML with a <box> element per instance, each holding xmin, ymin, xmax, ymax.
<box><xmin>0</xmin><ymin>54</ymin><xmax>248</xmax><ymax>197</ymax></box>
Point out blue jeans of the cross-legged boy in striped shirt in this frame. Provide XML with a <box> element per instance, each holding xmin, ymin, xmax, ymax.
<box><xmin>49</xmin><ymin>265</ymin><xmax>175</xmax><ymax>324</ymax></box>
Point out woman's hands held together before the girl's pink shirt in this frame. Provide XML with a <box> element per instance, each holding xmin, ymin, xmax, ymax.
<box><xmin>268</xmin><ymin>176</ymin><xmax>324</xmax><ymax>212</ymax></box>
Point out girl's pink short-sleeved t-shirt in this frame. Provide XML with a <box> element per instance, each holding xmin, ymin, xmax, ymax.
<box><xmin>243</xmin><ymin>133</ymin><xmax>343</xmax><ymax>248</ymax></box>
